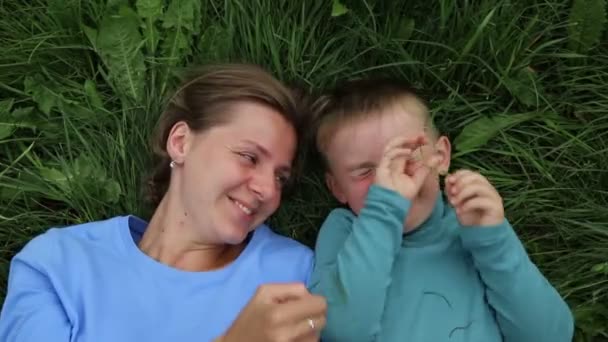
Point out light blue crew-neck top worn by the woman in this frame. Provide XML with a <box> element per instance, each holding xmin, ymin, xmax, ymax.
<box><xmin>0</xmin><ymin>216</ymin><xmax>313</xmax><ymax>342</ymax></box>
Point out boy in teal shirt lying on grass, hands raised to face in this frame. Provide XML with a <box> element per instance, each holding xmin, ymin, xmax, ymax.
<box><xmin>311</xmin><ymin>80</ymin><xmax>574</xmax><ymax>342</ymax></box>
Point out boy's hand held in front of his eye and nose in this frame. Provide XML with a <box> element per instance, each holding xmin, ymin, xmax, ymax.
<box><xmin>374</xmin><ymin>136</ymin><xmax>440</xmax><ymax>201</ymax></box>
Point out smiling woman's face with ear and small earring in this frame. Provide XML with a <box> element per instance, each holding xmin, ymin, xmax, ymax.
<box><xmin>168</xmin><ymin>102</ymin><xmax>297</xmax><ymax>244</ymax></box>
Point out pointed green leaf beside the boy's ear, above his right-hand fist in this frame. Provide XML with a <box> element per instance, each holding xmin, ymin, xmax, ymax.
<box><xmin>454</xmin><ymin>113</ymin><xmax>538</xmax><ymax>154</ymax></box>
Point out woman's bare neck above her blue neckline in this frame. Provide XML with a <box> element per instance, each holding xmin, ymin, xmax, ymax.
<box><xmin>138</xmin><ymin>196</ymin><xmax>246</xmax><ymax>272</ymax></box>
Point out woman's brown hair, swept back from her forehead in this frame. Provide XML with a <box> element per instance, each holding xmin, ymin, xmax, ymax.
<box><xmin>147</xmin><ymin>63</ymin><xmax>302</xmax><ymax>207</ymax></box>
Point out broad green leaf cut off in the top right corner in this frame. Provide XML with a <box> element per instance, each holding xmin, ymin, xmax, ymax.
<box><xmin>568</xmin><ymin>0</ymin><xmax>607</xmax><ymax>53</ymax></box>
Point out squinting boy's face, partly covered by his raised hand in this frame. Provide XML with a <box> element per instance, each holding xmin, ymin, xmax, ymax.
<box><xmin>325</xmin><ymin>105</ymin><xmax>450</xmax><ymax>231</ymax></box>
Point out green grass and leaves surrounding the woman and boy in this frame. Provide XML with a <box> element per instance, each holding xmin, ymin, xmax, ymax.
<box><xmin>0</xmin><ymin>0</ymin><xmax>608</xmax><ymax>341</ymax></box>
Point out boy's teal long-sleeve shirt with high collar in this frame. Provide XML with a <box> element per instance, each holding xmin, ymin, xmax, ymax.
<box><xmin>311</xmin><ymin>185</ymin><xmax>574</xmax><ymax>342</ymax></box>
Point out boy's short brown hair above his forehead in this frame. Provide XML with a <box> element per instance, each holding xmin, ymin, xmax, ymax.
<box><xmin>313</xmin><ymin>78</ymin><xmax>438</xmax><ymax>171</ymax></box>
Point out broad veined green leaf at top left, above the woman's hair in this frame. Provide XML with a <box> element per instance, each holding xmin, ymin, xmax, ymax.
<box><xmin>96</xmin><ymin>7</ymin><xmax>146</xmax><ymax>103</ymax></box>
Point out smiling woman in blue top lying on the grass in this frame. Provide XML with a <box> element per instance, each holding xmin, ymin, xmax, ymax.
<box><xmin>0</xmin><ymin>64</ymin><xmax>325</xmax><ymax>342</ymax></box>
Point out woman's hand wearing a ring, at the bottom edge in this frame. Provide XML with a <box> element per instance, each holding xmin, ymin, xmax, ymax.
<box><xmin>216</xmin><ymin>284</ymin><xmax>327</xmax><ymax>342</ymax></box>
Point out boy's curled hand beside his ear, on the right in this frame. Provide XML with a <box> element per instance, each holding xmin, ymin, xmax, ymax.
<box><xmin>445</xmin><ymin>170</ymin><xmax>505</xmax><ymax>226</ymax></box>
